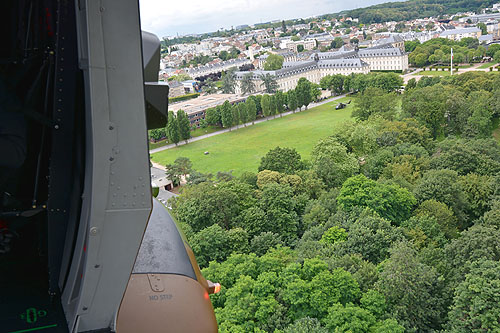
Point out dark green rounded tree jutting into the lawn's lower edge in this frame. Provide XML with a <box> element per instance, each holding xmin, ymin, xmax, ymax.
<box><xmin>259</xmin><ymin>147</ymin><xmax>303</xmax><ymax>174</ymax></box>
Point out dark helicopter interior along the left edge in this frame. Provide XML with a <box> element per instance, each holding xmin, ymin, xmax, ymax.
<box><xmin>0</xmin><ymin>0</ymin><xmax>85</xmax><ymax>332</ymax></box>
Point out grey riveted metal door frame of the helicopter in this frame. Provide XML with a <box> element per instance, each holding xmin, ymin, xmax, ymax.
<box><xmin>62</xmin><ymin>0</ymin><xmax>151</xmax><ymax>332</ymax></box>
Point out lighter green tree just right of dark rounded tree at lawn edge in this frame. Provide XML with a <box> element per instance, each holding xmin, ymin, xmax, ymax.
<box><xmin>311</xmin><ymin>138</ymin><xmax>359</xmax><ymax>187</ymax></box>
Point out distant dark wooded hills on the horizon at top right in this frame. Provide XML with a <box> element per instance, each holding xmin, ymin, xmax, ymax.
<box><xmin>323</xmin><ymin>0</ymin><xmax>498</xmax><ymax>24</ymax></box>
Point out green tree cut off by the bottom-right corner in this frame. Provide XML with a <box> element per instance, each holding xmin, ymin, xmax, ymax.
<box><xmin>448</xmin><ymin>259</ymin><xmax>500</xmax><ymax>332</ymax></box>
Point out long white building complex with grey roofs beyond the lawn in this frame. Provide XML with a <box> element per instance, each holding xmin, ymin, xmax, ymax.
<box><xmin>235</xmin><ymin>43</ymin><xmax>408</xmax><ymax>94</ymax></box>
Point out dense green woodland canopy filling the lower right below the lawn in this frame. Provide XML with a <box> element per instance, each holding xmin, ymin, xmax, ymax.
<box><xmin>167</xmin><ymin>68</ymin><xmax>500</xmax><ymax>333</ymax></box>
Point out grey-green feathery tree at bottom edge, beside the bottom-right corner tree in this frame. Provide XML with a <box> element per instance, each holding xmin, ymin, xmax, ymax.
<box><xmin>376</xmin><ymin>242</ymin><xmax>444</xmax><ymax>332</ymax></box>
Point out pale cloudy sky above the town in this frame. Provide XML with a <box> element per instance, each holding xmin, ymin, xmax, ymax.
<box><xmin>139</xmin><ymin>0</ymin><xmax>401</xmax><ymax>37</ymax></box>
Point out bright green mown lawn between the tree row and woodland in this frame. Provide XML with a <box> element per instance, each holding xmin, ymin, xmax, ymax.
<box><xmin>152</xmin><ymin>97</ymin><xmax>353</xmax><ymax>175</ymax></box>
